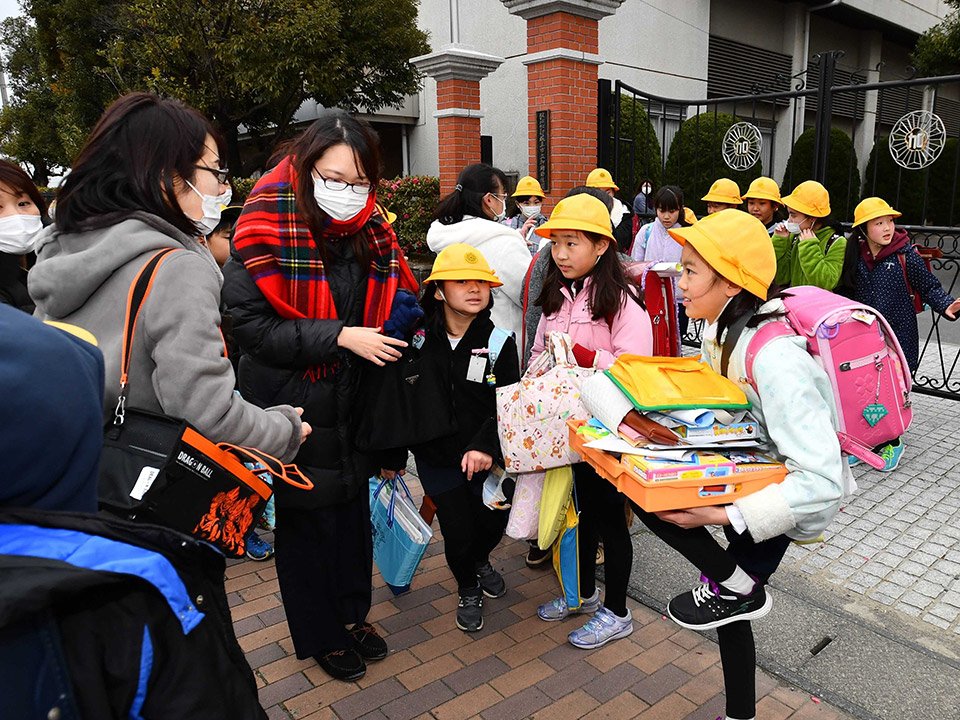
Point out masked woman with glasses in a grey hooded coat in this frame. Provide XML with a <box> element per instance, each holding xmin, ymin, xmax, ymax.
<box><xmin>29</xmin><ymin>93</ymin><xmax>310</xmax><ymax>461</ymax></box>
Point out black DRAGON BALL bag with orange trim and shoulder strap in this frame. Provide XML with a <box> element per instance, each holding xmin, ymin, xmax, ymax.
<box><xmin>98</xmin><ymin>248</ymin><xmax>313</xmax><ymax>557</ymax></box>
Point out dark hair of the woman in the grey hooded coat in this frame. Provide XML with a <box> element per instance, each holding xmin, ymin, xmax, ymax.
<box><xmin>54</xmin><ymin>92</ymin><xmax>226</xmax><ymax>237</ymax></box>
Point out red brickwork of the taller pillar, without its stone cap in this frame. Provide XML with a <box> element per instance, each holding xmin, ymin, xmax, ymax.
<box><xmin>527</xmin><ymin>13</ymin><xmax>598</xmax><ymax>206</ymax></box>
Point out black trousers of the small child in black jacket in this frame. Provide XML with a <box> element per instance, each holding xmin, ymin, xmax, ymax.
<box><xmin>417</xmin><ymin>463</ymin><xmax>509</xmax><ymax>590</ymax></box>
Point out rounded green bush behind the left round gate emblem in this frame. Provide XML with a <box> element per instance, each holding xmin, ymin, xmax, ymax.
<box><xmin>664</xmin><ymin>113</ymin><xmax>762</xmax><ymax>217</ymax></box>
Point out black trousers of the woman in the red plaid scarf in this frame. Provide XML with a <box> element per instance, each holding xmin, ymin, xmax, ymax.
<box><xmin>274</xmin><ymin>492</ymin><xmax>373</xmax><ymax>659</ymax></box>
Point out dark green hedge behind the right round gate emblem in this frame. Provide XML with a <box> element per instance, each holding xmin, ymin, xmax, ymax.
<box><xmin>863</xmin><ymin>135</ymin><xmax>960</xmax><ymax>225</ymax></box>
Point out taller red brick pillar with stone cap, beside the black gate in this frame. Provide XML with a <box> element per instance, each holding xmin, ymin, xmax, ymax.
<box><xmin>501</xmin><ymin>0</ymin><xmax>623</xmax><ymax>204</ymax></box>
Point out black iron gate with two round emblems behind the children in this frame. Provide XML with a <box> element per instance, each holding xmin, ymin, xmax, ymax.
<box><xmin>597</xmin><ymin>51</ymin><xmax>960</xmax><ymax>399</ymax></box>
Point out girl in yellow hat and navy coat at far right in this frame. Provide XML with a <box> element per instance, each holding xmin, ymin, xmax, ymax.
<box><xmin>837</xmin><ymin>197</ymin><xmax>960</xmax><ymax>472</ymax></box>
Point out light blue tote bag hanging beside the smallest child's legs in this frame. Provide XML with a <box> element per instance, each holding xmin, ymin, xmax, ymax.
<box><xmin>370</xmin><ymin>475</ymin><xmax>433</xmax><ymax>594</ymax></box>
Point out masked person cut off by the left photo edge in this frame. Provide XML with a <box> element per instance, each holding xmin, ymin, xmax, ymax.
<box><xmin>0</xmin><ymin>160</ymin><xmax>47</xmax><ymax>313</ymax></box>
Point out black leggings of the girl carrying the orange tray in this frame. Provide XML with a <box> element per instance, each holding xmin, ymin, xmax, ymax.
<box><xmin>634</xmin><ymin>506</ymin><xmax>790</xmax><ymax>718</ymax></box>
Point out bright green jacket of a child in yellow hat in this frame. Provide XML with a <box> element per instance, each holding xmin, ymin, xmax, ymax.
<box><xmin>770</xmin><ymin>227</ymin><xmax>847</xmax><ymax>290</ymax></box>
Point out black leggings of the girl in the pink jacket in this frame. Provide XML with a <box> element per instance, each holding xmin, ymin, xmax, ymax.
<box><xmin>573</xmin><ymin>463</ymin><xmax>633</xmax><ymax>617</ymax></box>
